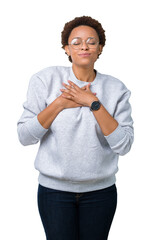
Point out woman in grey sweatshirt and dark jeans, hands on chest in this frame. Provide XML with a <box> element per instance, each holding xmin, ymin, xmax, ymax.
<box><xmin>18</xmin><ymin>16</ymin><xmax>133</xmax><ymax>240</ymax></box>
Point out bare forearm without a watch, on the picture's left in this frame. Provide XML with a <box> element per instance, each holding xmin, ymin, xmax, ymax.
<box><xmin>37</xmin><ymin>98</ymin><xmax>63</xmax><ymax>129</ymax></box>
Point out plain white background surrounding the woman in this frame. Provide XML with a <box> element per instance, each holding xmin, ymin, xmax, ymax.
<box><xmin>0</xmin><ymin>0</ymin><xmax>151</xmax><ymax>240</ymax></box>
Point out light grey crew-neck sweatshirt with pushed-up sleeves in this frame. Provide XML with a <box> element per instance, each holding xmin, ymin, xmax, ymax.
<box><xmin>17</xmin><ymin>66</ymin><xmax>134</xmax><ymax>192</ymax></box>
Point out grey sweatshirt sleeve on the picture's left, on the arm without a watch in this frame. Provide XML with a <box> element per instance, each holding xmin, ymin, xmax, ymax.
<box><xmin>17</xmin><ymin>75</ymin><xmax>48</xmax><ymax>146</ymax></box>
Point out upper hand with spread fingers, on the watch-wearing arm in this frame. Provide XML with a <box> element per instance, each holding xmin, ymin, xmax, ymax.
<box><xmin>60</xmin><ymin>80</ymin><xmax>98</xmax><ymax>107</ymax></box>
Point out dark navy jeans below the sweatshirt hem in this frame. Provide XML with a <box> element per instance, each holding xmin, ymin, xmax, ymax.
<box><xmin>38</xmin><ymin>185</ymin><xmax>117</xmax><ymax>240</ymax></box>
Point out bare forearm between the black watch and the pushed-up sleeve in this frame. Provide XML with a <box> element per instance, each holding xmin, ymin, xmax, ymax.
<box><xmin>93</xmin><ymin>105</ymin><xmax>118</xmax><ymax>136</ymax></box>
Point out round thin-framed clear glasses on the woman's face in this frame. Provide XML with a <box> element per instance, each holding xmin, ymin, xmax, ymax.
<box><xmin>69</xmin><ymin>37</ymin><xmax>99</xmax><ymax>50</ymax></box>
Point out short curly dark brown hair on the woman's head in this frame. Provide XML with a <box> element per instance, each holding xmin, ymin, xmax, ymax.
<box><xmin>61</xmin><ymin>16</ymin><xmax>106</xmax><ymax>62</ymax></box>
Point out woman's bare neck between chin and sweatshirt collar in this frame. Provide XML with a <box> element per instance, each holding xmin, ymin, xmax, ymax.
<box><xmin>72</xmin><ymin>64</ymin><xmax>95</xmax><ymax>82</ymax></box>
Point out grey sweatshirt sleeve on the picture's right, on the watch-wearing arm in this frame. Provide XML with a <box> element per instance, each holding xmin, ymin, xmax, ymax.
<box><xmin>105</xmin><ymin>90</ymin><xmax>134</xmax><ymax>155</ymax></box>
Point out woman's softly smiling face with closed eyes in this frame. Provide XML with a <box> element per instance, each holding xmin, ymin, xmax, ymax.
<box><xmin>65</xmin><ymin>26</ymin><xmax>103</xmax><ymax>67</ymax></box>
